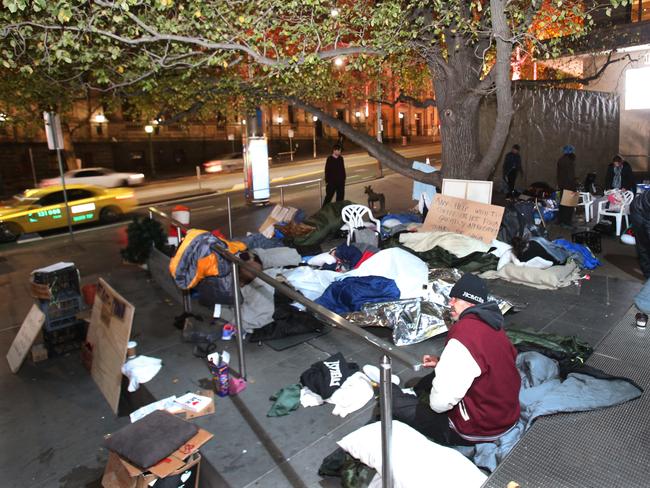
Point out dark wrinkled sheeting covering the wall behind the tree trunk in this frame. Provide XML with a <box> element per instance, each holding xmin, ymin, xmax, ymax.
<box><xmin>480</xmin><ymin>87</ymin><xmax>620</xmax><ymax>188</ymax></box>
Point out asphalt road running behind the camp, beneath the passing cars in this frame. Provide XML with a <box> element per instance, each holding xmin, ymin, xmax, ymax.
<box><xmin>0</xmin><ymin>144</ymin><xmax>440</xmax><ymax>248</ymax></box>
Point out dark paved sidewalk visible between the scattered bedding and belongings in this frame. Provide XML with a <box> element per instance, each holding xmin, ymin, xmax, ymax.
<box><xmin>0</xmin><ymin>175</ymin><xmax>641</xmax><ymax>488</ymax></box>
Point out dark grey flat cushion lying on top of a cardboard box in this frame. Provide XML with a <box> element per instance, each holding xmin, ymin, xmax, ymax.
<box><xmin>104</xmin><ymin>410</ymin><xmax>199</xmax><ymax>469</ymax></box>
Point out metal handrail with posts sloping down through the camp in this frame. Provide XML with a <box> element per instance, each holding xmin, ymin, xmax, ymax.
<box><xmin>149</xmin><ymin>204</ymin><xmax>422</xmax><ymax>488</ymax></box>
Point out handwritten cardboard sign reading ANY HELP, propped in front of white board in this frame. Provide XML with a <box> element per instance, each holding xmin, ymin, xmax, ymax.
<box><xmin>420</xmin><ymin>195</ymin><xmax>504</xmax><ymax>244</ymax></box>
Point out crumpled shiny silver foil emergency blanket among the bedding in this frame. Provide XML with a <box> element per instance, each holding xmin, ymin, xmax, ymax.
<box><xmin>346</xmin><ymin>268</ymin><xmax>512</xmax><ymax>346</ymax></box>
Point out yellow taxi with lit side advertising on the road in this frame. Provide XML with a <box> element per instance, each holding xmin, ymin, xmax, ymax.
<box><xmin>0</xmin><ymin>184</ymin><xmax>137</xmax><ymax>242</ymax></box>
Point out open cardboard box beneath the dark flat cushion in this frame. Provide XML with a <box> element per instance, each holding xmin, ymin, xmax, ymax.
<box><xmin>102</xmin><ymin>429</ymin><xmax>213</xmax><ymax>488</ymax></box>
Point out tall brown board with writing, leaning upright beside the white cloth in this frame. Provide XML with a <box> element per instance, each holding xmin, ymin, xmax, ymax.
<box><xmin>86</xmin><ymin>278</ymin><xmax>135</xmax><ymax>414</ymax></box>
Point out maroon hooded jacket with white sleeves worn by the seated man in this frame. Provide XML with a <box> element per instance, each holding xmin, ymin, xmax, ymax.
<box><xmin>429</xmin><ymin>302</ymin><xmax>521</xmax><ymax>442</ymax></box>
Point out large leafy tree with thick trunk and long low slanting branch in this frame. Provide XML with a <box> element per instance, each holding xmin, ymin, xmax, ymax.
<box><xmin>0</xmin><ymin>0</ymin><xmax>626</xmax><ymax>181</ymax></box>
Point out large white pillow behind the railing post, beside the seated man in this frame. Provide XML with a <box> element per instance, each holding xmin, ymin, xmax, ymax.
<box><xmin>338</xmin><ymin>420</ymin><xmax>487</xmax><ymax>488</ymax></box>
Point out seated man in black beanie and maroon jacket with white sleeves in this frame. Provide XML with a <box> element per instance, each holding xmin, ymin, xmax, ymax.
<box><xmin>393</xmin><ymin>273</ymin><xmax>521</xmax><ymax>445</ymax></box>
